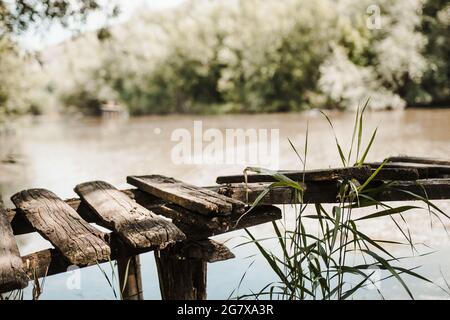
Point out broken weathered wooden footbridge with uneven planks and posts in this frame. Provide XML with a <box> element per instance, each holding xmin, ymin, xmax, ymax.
<box><xmin>0</xmin><ymin>157</ymin><xmax>450</xmax><ymax>299</ymax></box>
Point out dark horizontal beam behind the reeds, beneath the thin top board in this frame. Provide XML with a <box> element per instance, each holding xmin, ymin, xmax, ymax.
<box><xmin>218</xmin><ymin>179</ymin><xmax>450</xmax><ymax>204</ymax></box>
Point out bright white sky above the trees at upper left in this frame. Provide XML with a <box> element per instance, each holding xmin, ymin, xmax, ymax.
<box><xmin>18</xmin><ymin>0</ymin><xmax>186</xmax><ymax>51</ymax></box>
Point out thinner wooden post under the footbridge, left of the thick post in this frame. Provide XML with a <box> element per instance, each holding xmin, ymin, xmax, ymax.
<box><xmin>117</xmin><ymin>256</ymin><xmax>144</xmax><ymax>300</ymax></box>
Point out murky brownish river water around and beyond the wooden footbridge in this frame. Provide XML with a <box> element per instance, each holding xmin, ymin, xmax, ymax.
<box><xmin>0</xmin><ymin>109</ymin><xmax>450</xmax><ymax>299</ymax></box>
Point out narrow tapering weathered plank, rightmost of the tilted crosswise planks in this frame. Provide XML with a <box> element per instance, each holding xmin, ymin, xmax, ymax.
<box><xmin>127</xmin><ymin>175</ymin><xmax>245</xmax><ymax>215</ymax></box>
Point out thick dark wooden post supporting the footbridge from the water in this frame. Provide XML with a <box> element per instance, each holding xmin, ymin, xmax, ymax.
<box><xmin>155</xmin><ymin>247</ymin><xmax>207</xmax><ymax>300</ymax></box>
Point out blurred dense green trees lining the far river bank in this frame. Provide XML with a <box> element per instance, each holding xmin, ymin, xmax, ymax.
<box><xmin>0</xmin><ymin>0</ymin><xmax>450</xmax><ymax>115</ymax></box>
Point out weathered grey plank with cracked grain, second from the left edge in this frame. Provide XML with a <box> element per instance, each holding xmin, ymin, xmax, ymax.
<box><xmin>11</xmin><ymin>189</ymin><xmax>111</xmax><ymax>265</ymax></box>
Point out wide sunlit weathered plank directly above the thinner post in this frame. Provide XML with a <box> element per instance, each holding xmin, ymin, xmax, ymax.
<box><xmin>75</xmin><ymin>181</ymin><xmax>186</xmax><ymax>248</ymax></box>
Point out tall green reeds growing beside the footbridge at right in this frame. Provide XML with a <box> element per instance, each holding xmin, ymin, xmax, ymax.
<box><xmin>236</xmin><ymin>103</ymin><xmax>450</xmax><ymax>300</ymax></box>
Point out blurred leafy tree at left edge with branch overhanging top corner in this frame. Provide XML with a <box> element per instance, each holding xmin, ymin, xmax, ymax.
<box><xmin>0</xmin><ymin>0</ymin><xmax>119</xmax><ymax>116</ymax></box>
